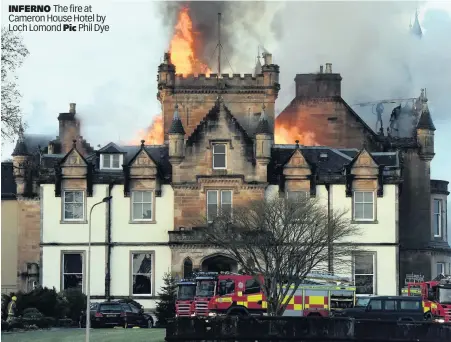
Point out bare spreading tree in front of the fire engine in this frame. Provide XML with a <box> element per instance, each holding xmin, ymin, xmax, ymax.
<box><xmin>203</xmin><ymin>198</ymin><xmax>358</xmax><ymax>316</ymax></box>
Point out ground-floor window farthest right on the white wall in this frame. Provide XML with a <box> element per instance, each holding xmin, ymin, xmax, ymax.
<box><xmin>354</xmin><ymin>254</ymin><xmax>375</xmax><ymax>295</ymax></box>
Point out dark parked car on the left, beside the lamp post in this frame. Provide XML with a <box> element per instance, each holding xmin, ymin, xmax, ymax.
<box><xmin>81</xmin><ymin>301</ymin><xmax>149</xmax><ymax>328</ymax></box>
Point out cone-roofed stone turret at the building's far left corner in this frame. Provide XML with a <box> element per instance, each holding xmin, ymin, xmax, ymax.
<box><xmin>12</xmin><ymin>123</ymin><xmax>32</xmax><ymax>196</ymax></box>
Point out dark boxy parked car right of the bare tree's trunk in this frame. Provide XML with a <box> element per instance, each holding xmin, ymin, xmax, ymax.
<box><xmin>336</xmin><ymin>296</ymin><xmax>424</xmax><ymax>321</ymax></box>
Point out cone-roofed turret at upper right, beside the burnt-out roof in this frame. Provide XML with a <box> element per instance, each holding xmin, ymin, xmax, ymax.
<box><xmin>416</xmin><ymin>89</ymin><xmax>435</xmax><ymax>161</ymax></box>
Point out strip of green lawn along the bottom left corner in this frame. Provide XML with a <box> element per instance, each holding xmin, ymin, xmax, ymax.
<box><xmin>2</xmin><ymin>328</ymin><xmax>166</xmax><ymax>342</ymax></box>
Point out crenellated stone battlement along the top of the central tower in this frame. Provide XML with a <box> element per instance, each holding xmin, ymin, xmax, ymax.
<box><xmin>170</xmin><ymin>73</ymin><xmax>265</xmax><ymax>88</ymax></box>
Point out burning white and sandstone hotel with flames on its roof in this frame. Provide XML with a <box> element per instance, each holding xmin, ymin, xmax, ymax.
<box><xmin>1</xmin><ymin>5</ymin><xmax>451</xmax><ymax>307</ymax></box>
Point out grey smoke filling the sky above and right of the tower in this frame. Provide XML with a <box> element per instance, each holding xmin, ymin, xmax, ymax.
<box><xmin>162</xmin><ymin>1</ymin><xmax>451</xmax><ymax>127</ymax></box>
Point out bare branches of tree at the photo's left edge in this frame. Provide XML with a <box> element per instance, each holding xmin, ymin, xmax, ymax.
<box><xmin>2</xmin><ymin>27</ymin><xmax>29</xmax><ymax>140</ymax></box>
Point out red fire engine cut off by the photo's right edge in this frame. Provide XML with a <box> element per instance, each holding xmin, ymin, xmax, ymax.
<box><xmin>402</xmin><ymin>274</ymin><xmax>451</xmax><ymax>323</ymax></box>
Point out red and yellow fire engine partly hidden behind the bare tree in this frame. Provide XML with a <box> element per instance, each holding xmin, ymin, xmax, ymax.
<box><xmin>193</xmin><ymin>272</ymin><xmax>356</xmax><ymax>316</ymax></box>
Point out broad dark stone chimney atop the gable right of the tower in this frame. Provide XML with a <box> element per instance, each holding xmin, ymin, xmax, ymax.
<box><xmin>294</xmin><ymin>63</ymin><xmax>342</xmax><ymax>98</ymax></box>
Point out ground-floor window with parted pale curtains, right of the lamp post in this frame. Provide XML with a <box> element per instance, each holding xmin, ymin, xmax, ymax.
<box><xmin>132</xmin><ymin>253</ymin><xmax>153</xmax><ymax>295</ymax></box>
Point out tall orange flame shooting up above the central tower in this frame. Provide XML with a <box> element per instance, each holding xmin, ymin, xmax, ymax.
<box><xmin>169</xmin><ymin>7</ymin><xmax>211</xmax><ymax>75</ymax></box>
